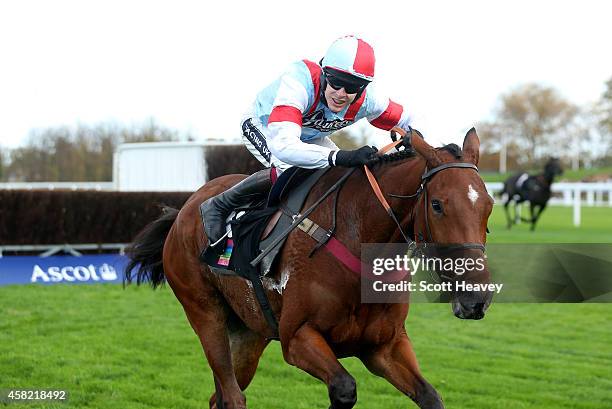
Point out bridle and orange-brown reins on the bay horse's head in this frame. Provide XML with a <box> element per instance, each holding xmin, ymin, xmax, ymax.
<box><xmin>364</xmin><ymin>129</ymin><xmax>485</xmax><ymax>253</ymax></box>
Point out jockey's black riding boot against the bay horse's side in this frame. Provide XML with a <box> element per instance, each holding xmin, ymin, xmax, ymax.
<box><xmin>200</xmin><ymin>169</ymin><xmax>272</xmax><ymax>251</ymax></box>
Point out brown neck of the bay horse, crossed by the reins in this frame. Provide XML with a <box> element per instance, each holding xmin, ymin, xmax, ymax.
<box><xmin>354</xmin><ymin>158</ymin><xmax>425</xmax><ymax>243</ymax></box>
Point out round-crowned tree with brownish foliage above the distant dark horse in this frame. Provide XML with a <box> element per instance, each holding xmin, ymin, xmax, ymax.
<box><xmin>480</xmin><ymin>84</ymin><xmax>578</xmax><ymax>165</ymax></box>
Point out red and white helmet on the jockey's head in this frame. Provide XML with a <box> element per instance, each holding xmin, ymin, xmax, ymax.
<box><xmin>321</xmin><ymin>35</ymin><xmax>376</xmax><ymax>82</ymax></box>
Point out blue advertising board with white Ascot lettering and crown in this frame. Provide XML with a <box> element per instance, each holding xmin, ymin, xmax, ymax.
<box><xmin>0</xmin><ymin>254</ymin><xmax>128</xmax><ymax>286</ymax></box>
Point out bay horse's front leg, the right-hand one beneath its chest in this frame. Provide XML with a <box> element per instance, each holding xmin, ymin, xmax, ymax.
<box><xmin>360</xmin><ymin>331</ymin><xmax>444</xmax><ymax>409</ymax></box>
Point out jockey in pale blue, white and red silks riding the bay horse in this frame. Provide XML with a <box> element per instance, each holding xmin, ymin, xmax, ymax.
<box><xmin>200</xmin><ymin>36</ymin><xmax>410</xmax><ymax>246</ymax></box>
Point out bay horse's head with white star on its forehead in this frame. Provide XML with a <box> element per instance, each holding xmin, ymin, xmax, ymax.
<box><xmin>411</xmin><ymin>128</ymin><xmax>493</xmax><ymax>319</ymax></box>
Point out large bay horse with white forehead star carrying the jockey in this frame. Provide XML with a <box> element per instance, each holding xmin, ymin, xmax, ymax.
<box><xmin>124</xmin><ymin>128</ymin><xmax>493</xmax><ymax>409</ymax></box>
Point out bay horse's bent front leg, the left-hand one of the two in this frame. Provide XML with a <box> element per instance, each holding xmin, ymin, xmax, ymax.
<box><xmin>281</xmin><ymin>324</ymin><xmax>357</xmax><ymax>409</ymax></box>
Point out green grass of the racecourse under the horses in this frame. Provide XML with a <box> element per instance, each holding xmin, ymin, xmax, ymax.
<box><xmin>0</xmin><ymin>206</ymin><xmax>612</xmax><ymax>409</ymax></box>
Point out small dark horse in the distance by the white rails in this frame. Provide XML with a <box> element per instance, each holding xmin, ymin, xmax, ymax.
<box><xmin>501</xmin><ymin>158</ymin><xmax>563</xmax><ymax>231</ymax></box>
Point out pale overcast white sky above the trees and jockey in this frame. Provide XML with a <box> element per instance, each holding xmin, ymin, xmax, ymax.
<box><xmin>0</xmin><ymin>0</ymin><xmax>612</xmax><ymax>147</ymax></box>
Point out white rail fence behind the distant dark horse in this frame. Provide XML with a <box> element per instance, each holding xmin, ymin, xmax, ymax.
<box><xmin>486</xmin><ymin>182</ymin><xmax>612</xmax><ymax>226</ymax></box>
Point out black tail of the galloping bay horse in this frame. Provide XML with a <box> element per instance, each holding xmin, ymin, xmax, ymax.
<box><xmin>123</xmin><ymin>206</ymin><xmax>178</xmax><ymax>288</ymax></box>
